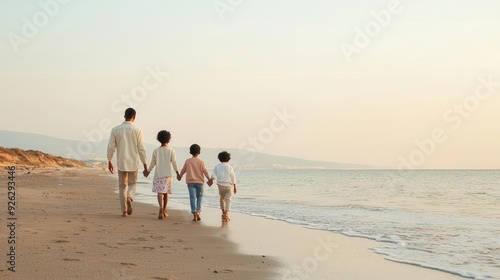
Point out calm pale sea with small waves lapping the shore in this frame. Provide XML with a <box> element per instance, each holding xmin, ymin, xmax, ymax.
<box><xmin>139</xmin><ymin>170</ymin><xmax>500</xmax><ymax>279</ymax></box>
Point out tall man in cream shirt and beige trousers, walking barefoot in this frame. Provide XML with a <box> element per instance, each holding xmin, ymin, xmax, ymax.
<box><xmin>108</xmin><ymin>108</ymin><xmax>148</xmax><ymax>217</ymax></box>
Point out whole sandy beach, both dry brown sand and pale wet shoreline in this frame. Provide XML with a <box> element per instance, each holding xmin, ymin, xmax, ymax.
<box><xmin>0</xmin><ymin>169</ymin><xmax>464</xmax><ymax>280</ymax></box>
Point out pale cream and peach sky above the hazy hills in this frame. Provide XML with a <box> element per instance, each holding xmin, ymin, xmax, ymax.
<box><xmin>0</xmin><ymin>0</ymin><xmax>500</xmax><ymax>169</ymax></box>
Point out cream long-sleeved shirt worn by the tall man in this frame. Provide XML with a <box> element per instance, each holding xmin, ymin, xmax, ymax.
<box><xmin>104</xmin><ymin>121</ymin><xmax>147</xmax><ymax>172</ymax></box>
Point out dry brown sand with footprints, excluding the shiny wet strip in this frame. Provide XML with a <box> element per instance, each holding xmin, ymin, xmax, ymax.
<box><xmin>0</xmin><ymin>169</ymin><xmax>276</xmax><ymax>280</ymax></box>
